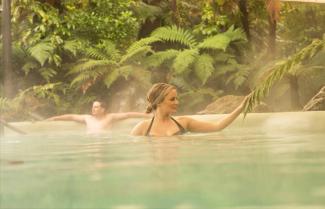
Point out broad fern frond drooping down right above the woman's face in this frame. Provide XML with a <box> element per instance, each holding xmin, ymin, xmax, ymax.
<box><xmin>173</xmin><ymin>49</ymin><xmax>199</xmax><ymax>74</ymax></box>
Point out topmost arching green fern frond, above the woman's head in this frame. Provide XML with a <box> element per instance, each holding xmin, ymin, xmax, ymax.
<box><xmin>151</xmin><ymin>25</ymin><xmax>197</xmax><ymax>48</ymax></box>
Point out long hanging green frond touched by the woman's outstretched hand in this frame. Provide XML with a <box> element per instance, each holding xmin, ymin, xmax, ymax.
<box><xmin>244</xmin><ymin>40</ymin><xmax>325</xmax><ymax>115</ymax></box>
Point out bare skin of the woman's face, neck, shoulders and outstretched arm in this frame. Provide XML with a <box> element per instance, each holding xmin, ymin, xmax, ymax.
<box><xmin>131</xmin><ymin>89</ymin><xmax>247</xmax><ymax>137</ymax></box>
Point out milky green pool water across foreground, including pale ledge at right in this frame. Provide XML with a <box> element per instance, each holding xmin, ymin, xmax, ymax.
<box><xmin>0</xmin><ymin>112</ymin><xmax>325</xmax><ymax>209</ymax></box>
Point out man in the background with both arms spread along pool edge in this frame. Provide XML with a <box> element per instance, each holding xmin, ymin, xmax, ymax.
<box><xmin>47</xmin><ymin>101</ymin><xmax>152</xmax><ymax>133</ymax></box>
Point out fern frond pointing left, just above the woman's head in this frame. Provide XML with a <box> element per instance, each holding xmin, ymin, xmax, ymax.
<box><xmin>144</xmin><ymin>49</ymin><xmax>180</xmax><ymax>67</ymax></box>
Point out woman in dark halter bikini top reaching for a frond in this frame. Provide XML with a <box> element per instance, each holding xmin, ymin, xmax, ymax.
<box><xmin>131</xmin><ymin>83</ymin><xmax>248</xmax><ymax>136</ymax></box>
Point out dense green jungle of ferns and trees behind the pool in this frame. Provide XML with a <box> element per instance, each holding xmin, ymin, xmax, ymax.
<box><xmin>0</xmin><ymin>0</ymin><xmax>325</xmax><ymax>120</ymax></box>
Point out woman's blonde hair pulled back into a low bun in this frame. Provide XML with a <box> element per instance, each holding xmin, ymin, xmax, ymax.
<box><xmin>146</xmin><ymin>83</ymin><xmax>176</xmax><ymax>113</ymax></box>
